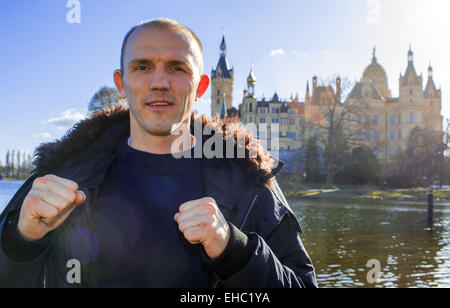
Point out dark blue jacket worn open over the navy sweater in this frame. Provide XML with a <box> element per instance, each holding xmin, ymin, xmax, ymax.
<box><xmin>0</xmin><ymin>110</ymin><xmax>317</xmax><ymax>288</ymax></box>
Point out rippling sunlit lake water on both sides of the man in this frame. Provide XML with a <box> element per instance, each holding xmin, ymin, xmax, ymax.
<box><xmin>0</xmin><ymin>181</ymin><xmax>450</xmax><ymax>287</ymax></box>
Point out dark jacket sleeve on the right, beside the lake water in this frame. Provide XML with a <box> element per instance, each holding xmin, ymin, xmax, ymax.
<box><xmin>216</xmin><ymin>184</ymin><xmax>317</xmax><ymax>288</ymax></box>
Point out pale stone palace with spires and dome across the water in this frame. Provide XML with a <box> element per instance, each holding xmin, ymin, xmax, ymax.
<box><xmin>211</xmin><ymin>37</ymin><xmax>443</xmax><ymax>161</ymax></box>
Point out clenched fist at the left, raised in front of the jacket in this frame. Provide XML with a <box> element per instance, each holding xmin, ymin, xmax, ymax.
<box><xmin>17</xmin><ymin>174</ymin><xmax>86</xmax><ymax>241</ymax></box>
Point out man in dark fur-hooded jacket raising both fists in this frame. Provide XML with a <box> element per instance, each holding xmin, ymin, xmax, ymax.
<box><xmin>0</xmin><ymin>19</ymin><xmax>316</xmax><ymax>287</ymax></box>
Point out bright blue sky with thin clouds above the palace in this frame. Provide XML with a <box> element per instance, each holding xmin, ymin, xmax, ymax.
<box><xmin>0</xmin><ymin>0</ymin><xmax>450</xmax><ymax>162</ymax></box>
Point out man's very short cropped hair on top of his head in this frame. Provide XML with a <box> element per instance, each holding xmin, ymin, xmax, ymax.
<box><xmin>120</xmin><ymin>18</ymin><xmax>203</xmax><ymax>74</ymax></box>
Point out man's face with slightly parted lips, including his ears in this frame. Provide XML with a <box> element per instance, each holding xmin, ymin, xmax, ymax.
<box><xmin>115</xmin><ymin>28</ymin><xmax>209</xmax><ymax>136</ymax></box>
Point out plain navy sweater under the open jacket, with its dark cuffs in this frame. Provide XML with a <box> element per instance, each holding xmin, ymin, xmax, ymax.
<box><xmin>2</xmin><ymin>140</ymin><xmax>255</xmax><ymax>287</ymax></box>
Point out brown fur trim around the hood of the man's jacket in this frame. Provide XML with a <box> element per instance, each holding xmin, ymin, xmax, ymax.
<box><xmin>33</xmin><ymin>107</ymin><xmax>282</xmax><ymax>186</ymax></box>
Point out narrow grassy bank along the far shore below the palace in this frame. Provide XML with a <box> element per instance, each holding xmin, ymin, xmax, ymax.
<box><xmin>277</xmin><ymin>176</ymin><xmax>450</xmax><ymax>200</ymax></box>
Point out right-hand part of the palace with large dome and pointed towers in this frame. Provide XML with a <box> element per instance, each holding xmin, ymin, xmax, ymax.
<box><xmin>345</xmin><ymin>48</ymin><xmax>443</xmax><ymax>160</ymax></box>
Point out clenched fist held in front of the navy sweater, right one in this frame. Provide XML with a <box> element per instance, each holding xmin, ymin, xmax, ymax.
<box><xmin>174</xmin><ymin>197</ymin><xmax>230</xmax><ymax>259</ymax></box>
